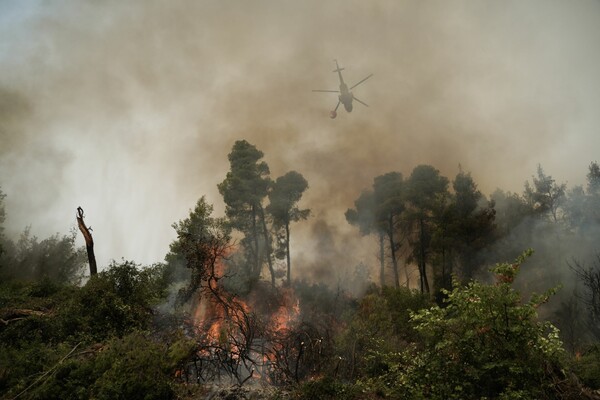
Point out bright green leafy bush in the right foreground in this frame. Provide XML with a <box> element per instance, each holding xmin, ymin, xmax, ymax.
<box><xmin>360</xmin><ymin>252</ymin><xmax>563</xmax><ymax>399</ymax></box>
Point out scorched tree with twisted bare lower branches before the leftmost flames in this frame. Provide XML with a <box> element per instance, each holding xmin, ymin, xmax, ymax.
<box><xmin>180</xmin><ymin>226</ymin><xmax>262</xmax><ymax>386</ymax></box>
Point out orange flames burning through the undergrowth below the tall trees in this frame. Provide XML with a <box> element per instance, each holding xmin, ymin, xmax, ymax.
<box><xmin>193</xmin><ymin>260</ymin><xmax>309</xmax><ymax>385</ymax></box>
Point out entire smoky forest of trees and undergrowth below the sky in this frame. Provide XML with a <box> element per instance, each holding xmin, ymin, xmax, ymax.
<box><xmin>0</xmin><ymin>140</ymin><xmax>600</xmax><ymax>400</ymax></box>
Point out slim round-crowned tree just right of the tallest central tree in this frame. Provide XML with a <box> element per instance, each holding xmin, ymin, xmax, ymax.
<box><xmin>266</xmin><ymin>171</ymin><xmax>310</xmax><ymax>285</ymax></box>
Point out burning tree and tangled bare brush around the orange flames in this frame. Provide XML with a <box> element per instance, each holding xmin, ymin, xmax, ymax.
<box><xmin>167</xmin><ymin>191</ymin><xmax>332</xmax><ymax>386</ymax></box>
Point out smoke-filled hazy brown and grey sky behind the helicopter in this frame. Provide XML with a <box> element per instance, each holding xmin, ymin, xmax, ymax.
<box><xmin>0</xmin><ymin>0</ymin><xmax>600</xmax><ymax>278</ymax></box>
